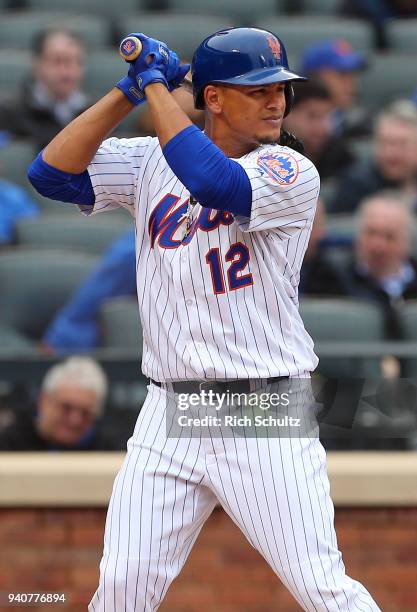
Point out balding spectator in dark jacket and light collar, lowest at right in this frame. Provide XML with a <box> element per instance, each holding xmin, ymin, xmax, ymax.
<box><xmin>341</xmin><ymin>192</ymin><xmax>417</xmax><ymax>339</ymax></box>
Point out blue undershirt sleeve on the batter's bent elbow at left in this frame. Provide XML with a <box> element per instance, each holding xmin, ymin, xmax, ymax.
<box><xmin>28</xmin><ymin>151</ymin><xmax>95</xmax><ymax>205</ymax></box>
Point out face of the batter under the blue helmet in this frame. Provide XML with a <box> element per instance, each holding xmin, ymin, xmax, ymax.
<box><xmin>211</xmin><ymin>83</ymin><xmax>285</xmax><ymax>151</ymax></box>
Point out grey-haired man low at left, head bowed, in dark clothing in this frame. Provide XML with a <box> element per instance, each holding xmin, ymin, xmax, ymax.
<box><xmin>0</xmin><ymin>357</ymin><xmax>123</xmax><ymax>451</ymax></box>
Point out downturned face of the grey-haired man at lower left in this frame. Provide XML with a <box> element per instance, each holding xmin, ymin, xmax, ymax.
<box><xmin>37</xmin><ymin>384</ymin><xmax>99</xmax><ymax>447</ymax></box>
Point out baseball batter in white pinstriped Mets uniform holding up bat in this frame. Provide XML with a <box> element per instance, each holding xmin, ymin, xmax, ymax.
<box><xmin>29</xmin><ymin>28</ymin><xmax>379</xmax><ymax>612</ymax></box>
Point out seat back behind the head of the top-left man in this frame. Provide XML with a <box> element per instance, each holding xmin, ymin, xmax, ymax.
<box><xmin>0</xmin><ymin>11</ymin><xmax>112</xmax><ymax>50</ymax></box>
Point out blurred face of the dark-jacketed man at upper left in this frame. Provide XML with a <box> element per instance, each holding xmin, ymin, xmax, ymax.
<box><xmin>34</xmin><ymin>32</ymin><xmax>84</xmax><ymax>100</ymax></box>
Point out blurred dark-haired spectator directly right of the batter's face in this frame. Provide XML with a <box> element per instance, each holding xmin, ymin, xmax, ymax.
<box><xmin>284</xmin><ymin>81</ymin><xmax>354</xmax><ymax>180</ymax></box>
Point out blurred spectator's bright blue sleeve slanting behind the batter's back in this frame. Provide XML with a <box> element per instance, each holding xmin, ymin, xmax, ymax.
<box><xmin>43</xmin><ymin>227</ymin><xmax>136</xmax><ymax>355</ymax></box>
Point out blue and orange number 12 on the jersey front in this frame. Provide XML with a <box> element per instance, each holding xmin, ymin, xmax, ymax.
<box><xmin>206</xmin><ymin>242</ymin><xmax>253</xmax><ymax>294</ymax></box>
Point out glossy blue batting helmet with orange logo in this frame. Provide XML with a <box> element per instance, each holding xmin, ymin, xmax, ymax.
<box><xmin>191</xmin><ymin>28</ymin><xmax>306</xmax><ymax>116</ymax></box>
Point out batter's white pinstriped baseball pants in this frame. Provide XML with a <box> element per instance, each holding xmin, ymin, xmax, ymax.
<box><xmin>88</xmin><ymin>385</ymin><xmax>380</xmax><ymax>612</ymax></box>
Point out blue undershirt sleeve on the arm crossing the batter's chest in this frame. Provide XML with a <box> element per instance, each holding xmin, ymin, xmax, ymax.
<box><xmin>162</xmin><ymin>125</ymin><xmax>252</xmax><ymax>217</ymax></box>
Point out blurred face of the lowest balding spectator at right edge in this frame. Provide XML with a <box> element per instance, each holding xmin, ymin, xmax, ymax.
<box><xmin>357</xmin><ymin>200</ymin><xmax>409</xmax><ymax>278</ymax></box>
